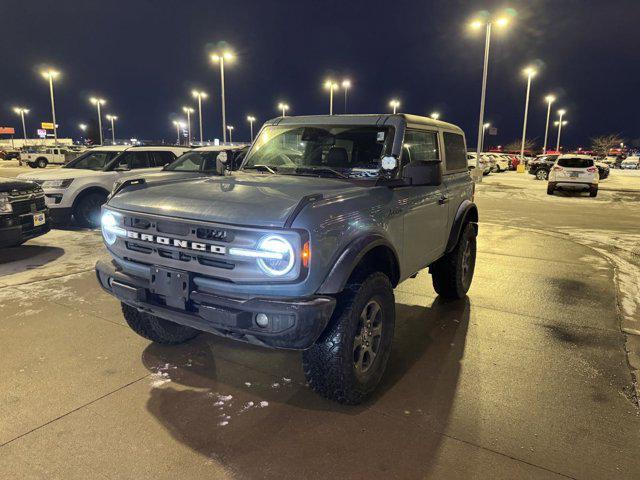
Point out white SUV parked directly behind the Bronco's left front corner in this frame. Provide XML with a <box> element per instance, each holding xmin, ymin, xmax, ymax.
<box><xmin>18</xmin><ymin>145</ymin><xmax>189</xmax><ymax>227</ymax></box>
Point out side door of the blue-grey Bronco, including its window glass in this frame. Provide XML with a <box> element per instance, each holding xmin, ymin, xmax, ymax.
<box><xmin>396</xmin><ymin>130</ymin><xmax>448</xmax><ymax>273</ymax></box>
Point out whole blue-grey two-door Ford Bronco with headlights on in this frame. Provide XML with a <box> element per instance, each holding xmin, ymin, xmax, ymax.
<box><xmin>96</xmin><ymin>114</ymin><xmax>478</xmax><ymax>404</ymax></box>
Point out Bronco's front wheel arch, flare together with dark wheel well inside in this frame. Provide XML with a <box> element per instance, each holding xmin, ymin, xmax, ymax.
<box><xmin>318</xmin><ymin>234</ymin><xmax>400</xmax><ymax>294</ymax></box>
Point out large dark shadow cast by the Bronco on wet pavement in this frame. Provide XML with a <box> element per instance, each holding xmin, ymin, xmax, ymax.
<box><xmin>142</xmin><ymin>298</ymin><xmax>470</xmax><ymax>477</ymax></box>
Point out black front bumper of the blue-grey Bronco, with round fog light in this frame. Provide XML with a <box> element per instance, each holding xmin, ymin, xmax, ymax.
<box><xmin>96</xmin><ymin>261</ymin><xmax>336</xmax><ymax>350</ymax></box>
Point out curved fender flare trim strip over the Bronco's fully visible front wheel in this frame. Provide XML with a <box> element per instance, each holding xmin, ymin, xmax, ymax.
<box><xmin>318</xmin><ymin>233</ymin><xmax>400</xmax><ymax>295</ymax></box>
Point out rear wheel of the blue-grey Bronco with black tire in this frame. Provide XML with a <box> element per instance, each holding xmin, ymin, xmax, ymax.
<box><xmin>430</xmin><ymin>223</ymin><xmax>476</xmax><ymax>298</ymax></box>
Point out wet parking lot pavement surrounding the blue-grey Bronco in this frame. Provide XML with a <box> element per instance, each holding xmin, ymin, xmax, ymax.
<box><xmin>0</xmin><ymin>171</ymin><xmax>640</xmax><ymax>479</ymax></box>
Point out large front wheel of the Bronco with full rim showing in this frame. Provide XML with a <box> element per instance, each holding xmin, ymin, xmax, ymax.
<box><xmin>302</xmin><ymin>272</ymin><xmax>395</xmax><ymax>405</ymax></box>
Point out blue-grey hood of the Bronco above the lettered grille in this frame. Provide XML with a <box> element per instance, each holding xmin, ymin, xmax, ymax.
<box><xmin>108</xmin><ymin>172</ymin><xmax>371</xmax><ymax>227</ymax></box>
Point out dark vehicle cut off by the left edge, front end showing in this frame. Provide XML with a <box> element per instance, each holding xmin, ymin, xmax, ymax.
<box><xmin>0</xmin><ymin>177</ymin><xmax>49</xmax><ymax>247</ymax></box>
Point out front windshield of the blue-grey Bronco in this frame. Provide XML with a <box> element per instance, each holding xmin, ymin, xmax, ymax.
<box><xmin>243</xmin><ymin>125</ymin><xmax>393</xmax><ymax>178</ymax></box>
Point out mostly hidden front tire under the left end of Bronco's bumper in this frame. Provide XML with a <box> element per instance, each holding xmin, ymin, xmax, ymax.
<box><xmin>121</xmin><ymin>303</ymin><xmax>200</xmax><ymax>345</ymax></box>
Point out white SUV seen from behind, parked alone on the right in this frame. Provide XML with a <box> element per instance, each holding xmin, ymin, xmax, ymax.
<box><xmin>547</xmin><ymin>155</ymin><xmax>600</xmax><ymax>197</ymax></box>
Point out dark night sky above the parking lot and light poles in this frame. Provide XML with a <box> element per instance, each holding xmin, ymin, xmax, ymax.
<box><xmin>0</xmin><ymin>0</ymin><xmax>640</xmax><ymax>146</ymax></box>
